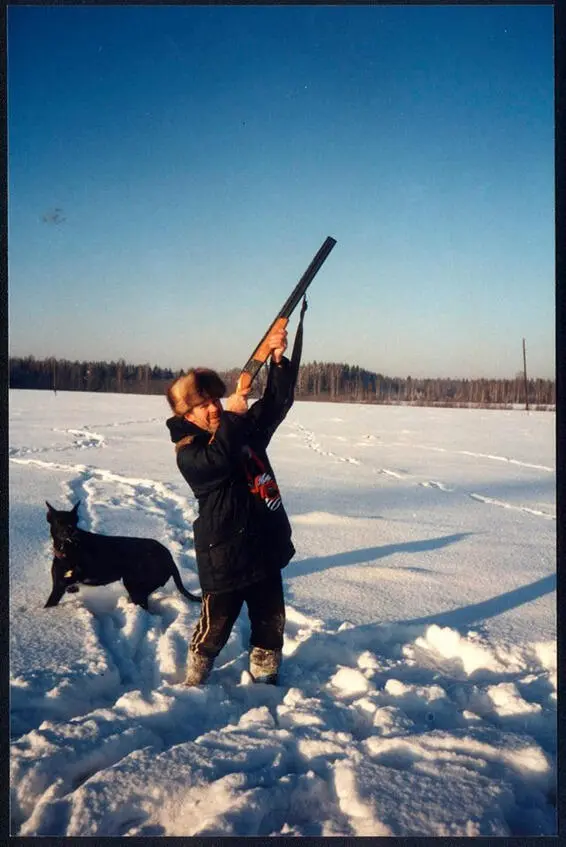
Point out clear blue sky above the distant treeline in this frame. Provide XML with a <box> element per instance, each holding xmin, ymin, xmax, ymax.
<box><xmin>8</xmin><ymin>1</ymin><xmax>555</xmax><ymax>378</ymax></box>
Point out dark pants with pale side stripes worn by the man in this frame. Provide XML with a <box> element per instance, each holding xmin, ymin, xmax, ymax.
<box><xmin>190</xmin><ymin>571</ymin><xmax>285</xmax><ymax>659</ymax></box>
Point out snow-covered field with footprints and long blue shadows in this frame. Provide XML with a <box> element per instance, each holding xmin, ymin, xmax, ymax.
<box><xmin>10</xmin><ymin>391</ymin><xmax>556</xmax><ymax>836</ymax></box>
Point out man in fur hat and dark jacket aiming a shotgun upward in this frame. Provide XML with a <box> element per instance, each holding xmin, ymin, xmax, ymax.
<box><xmin>167</xmin><ymin>329</ymin><xmax>296</xmax><ymax>685</ymax></box>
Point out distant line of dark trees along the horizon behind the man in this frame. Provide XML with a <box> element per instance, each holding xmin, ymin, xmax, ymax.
<box><xmin>10</xmin><ymin>356</ymin><xmax>556</xmax><ymax>408</ymax></box>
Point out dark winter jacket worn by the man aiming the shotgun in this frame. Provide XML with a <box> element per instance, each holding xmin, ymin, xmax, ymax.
<box><xmin>167</xmin><ymin>358</ymin><xmax>295</xmax><ymax>594</ymax></box>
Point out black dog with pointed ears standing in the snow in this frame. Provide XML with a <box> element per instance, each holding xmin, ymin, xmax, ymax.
<box><xmin>44</xmin><ymin>500</ymin><xmax>201</xmax><ymax>609</ymax></box>
